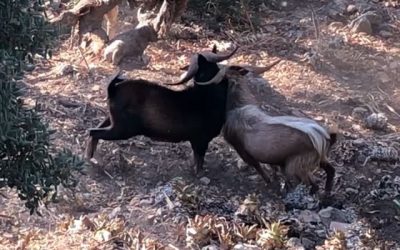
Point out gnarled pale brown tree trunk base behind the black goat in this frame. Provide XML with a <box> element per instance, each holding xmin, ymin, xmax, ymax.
<box><xmin>51</xmin><ymin>0</ymin><xmax>188</xmax><ymax>61</ymax></box>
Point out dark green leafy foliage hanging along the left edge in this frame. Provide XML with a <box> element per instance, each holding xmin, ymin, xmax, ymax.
<box><xmin>0</xmin><ymin>0</ymin><xmax>83</xmax><ymax>214</ymax></box>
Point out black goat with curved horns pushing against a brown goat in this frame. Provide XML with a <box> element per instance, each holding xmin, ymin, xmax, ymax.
<box><xmin>86</xmin><ymin>47</ymin><xmax>238</xmax><ymax>173</ymax></box>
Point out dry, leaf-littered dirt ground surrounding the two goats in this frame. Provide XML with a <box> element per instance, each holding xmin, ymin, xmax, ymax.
<box><xmin>0</xmin><ymin>1</ymin><xmax>400</xmax><ymax>249</ymax></box>
